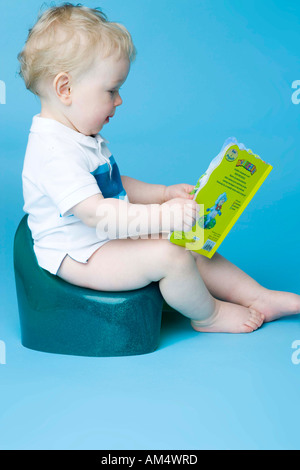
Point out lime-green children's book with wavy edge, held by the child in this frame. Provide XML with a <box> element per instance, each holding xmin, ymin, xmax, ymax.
<box><xmin>169</xmin><ymin>137</ymin><xmax>273</xmax><ymax>258</ymax></box>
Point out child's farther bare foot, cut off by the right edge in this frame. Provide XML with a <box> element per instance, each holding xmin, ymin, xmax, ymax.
<box><xmin>249</xmin><ymin>288</ymin><xmax>300</xmax><ymax>323</ymax></box>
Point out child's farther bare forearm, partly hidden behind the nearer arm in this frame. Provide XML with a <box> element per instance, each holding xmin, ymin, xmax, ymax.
<box><xmin>121</xmin><ymin>176</ymin><xmax>167</xmax><ymax>204</ymax></box>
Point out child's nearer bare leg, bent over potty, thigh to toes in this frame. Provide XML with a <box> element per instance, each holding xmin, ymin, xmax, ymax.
<box><xmin>58</xmin><ymin>239</ymin><xmax>263</xmax><ymax>333</ymax></box>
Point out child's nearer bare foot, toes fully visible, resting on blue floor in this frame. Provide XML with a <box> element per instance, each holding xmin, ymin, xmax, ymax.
<box><xmin>191</xmin><ymin>300</ymin><xmax>264</xmax><ymax>333</ymax></box>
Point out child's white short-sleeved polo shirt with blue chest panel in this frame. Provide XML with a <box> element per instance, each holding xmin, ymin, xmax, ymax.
<box><xmin>22</xmin><ymin>114</ymin><xmax>128</xmax><ymax>274</ymax></box>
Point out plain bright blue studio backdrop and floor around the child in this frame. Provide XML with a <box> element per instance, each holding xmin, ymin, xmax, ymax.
<box><xmin>0</xmin><ymin>0</ymin><xmax>300</xmax><ymax>449</ymax></box>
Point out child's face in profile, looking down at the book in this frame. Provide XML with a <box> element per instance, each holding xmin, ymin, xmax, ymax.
<box><xmin>68</xmin><ymin>56</ymin><xmax>130</xmax><ymax>135</ymax></box>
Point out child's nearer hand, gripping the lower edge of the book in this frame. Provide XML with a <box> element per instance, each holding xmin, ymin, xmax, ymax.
<box><xmin>161</xmin><ymin>198</ymin><xmax>200</xmax><ymax>232</ymax></box>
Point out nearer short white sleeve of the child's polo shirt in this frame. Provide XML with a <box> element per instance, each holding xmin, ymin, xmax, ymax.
<box><xmin>39</xmin><ymin>149</ymin><xmax>101</xmax><ymax>216</ymax></box>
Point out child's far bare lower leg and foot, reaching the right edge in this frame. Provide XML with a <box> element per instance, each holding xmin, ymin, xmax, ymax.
<box><xmin>192</xmin><ymin>253</ymin><xmax>300</xmax><ymax>322</ymax></box>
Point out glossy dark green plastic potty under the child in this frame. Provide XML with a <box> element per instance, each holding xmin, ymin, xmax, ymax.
<box><xmin>14</xmin><ymin>215</ymin><xmax>164</xmax><ymax>357</ymax></box>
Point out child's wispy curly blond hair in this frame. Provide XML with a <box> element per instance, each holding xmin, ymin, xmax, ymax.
<box><xmin>18</xmin><ymin>2</ymin><xmax>136</xmax><ymax>95</ymax></box>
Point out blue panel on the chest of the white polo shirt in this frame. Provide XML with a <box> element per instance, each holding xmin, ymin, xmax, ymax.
<box><xmin>92</xmin><ymin>155</ymin><xmax>126</xmax><ymax>199</ymax></box>
